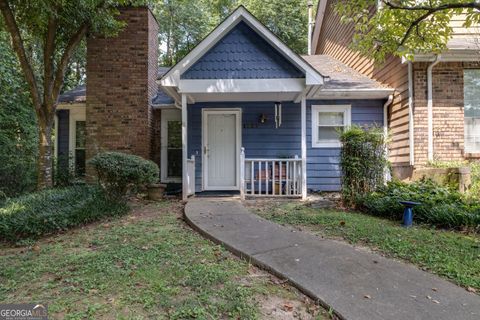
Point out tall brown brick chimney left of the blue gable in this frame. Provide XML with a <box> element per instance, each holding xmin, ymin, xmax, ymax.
<box><xmin>86</xmin><ymin>7</ymin><xmax>158</xmax><ymax>168</ymax></box>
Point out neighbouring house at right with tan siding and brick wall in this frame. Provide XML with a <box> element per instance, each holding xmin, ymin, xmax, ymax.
<box><xmin>312</xmin><ymin>0</ymin><xmax>480</xmax><ymax>178</ymax></box>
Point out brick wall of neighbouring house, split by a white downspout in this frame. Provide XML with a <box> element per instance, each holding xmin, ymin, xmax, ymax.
<box><xmin>413</xmin><ymin>62</ymin><xmax>480</xmax><ymax>167</ymax></box>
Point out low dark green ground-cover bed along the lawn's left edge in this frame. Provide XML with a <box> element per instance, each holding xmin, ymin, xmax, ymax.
<box><xmin>0</xmin><ymin>185</ymin><xmax>128</xmax><ymax>241</ymax></box>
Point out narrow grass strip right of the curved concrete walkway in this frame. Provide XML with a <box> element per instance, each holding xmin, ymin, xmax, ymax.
<box><xmin>253</xmin><ymin>202</ymin><xmax>480</xmax><ymax>291</ymax></box>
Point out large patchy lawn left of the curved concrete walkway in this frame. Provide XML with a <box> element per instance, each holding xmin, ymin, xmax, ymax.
<box><xmin>0</xmin><ymin>201</ymin><xmax>328</xmax><ymax>319</ymax></box>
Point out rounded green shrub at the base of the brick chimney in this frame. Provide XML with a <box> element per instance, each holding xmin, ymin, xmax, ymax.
<box><xmin>89</xmin><ymin>152</ymin><xmax>158</xmax><ymax>200</ymax></box>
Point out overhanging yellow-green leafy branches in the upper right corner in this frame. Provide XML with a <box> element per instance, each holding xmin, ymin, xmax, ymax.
<box><xmin>335</xmin><ymin>0</ymin><xmax>480</xmax><ymax>61</ymax></box>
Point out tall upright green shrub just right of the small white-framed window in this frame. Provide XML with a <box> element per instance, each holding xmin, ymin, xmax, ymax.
<box><xmin>340</xmin><ymin>126</ymin><xmax>388</xmax><ymax>205</ymax></box>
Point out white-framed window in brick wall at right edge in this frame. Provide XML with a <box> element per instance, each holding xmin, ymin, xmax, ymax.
<box><xmin>463</xmin><ymin>69</ymin><xmax>480</xmax><ymax>153</ymax></box>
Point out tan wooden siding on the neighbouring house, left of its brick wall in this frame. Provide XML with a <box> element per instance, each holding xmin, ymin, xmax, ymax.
<box><xmin>314</xmin><ymin>0</ymin><xmax>410</xmax><ymax>171</ymax></box>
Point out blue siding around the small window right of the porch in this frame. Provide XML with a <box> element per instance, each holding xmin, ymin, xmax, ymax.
<box><xmin>307</xmin><ymin>100</ymin><xmax>384</xmax><ymax>191</ymax></box>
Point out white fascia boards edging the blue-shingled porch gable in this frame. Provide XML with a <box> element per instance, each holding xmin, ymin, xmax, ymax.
<box><xmin>160</xmin><ymin>6</ymin><xmax>323</xmax><ymax>87</ymax></box>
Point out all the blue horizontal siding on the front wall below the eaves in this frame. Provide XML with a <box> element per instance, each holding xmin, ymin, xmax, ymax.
<box><xmin>188</xmin><ymin>100</ymin><xmax>383</xmax><ymax>191</ymax></box>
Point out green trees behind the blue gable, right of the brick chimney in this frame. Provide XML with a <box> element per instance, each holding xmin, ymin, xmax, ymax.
<box><xmin>156</xmin><ymin>0</ymin><xmax>318</xmax><ymax>65</ymax></box>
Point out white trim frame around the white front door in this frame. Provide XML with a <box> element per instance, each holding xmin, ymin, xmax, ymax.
<box><xmin>201</xmin><ymin>108</ymin><xmax>242</xmax><ymax>191</ymax></box>
